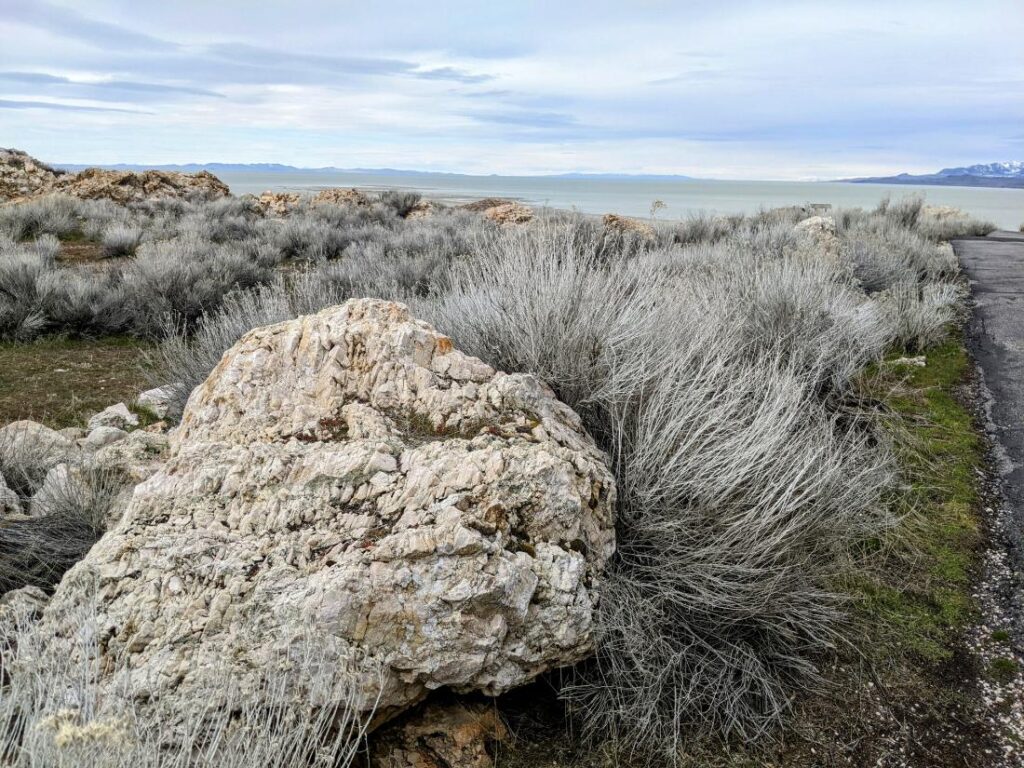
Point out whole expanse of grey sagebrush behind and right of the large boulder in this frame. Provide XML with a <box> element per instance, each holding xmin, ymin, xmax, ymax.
<box><xmin>0</xmin><ymin>194</ymin><xmax>990</xmax><ymax>760</ymax></box>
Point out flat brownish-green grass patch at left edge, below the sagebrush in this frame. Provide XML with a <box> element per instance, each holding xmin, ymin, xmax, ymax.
<box><xmin>0</xmin><ymin>337</ymin><xmax>147</xmax><ymax>429</ymax></box>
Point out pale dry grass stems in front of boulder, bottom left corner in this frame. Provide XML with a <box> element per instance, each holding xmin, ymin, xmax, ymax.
<box><xmin>0</xmin><ymin>574</ymin><xmax>381</xmax><ymax>768</ymax></box>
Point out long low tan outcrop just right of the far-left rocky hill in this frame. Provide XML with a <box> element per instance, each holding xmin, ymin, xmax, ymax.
<box><xmin>52</xmin><ymin>168</ymin><xmax>230</xmax><ymax>205</ymax></box>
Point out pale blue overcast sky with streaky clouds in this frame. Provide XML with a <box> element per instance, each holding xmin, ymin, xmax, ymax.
<box><xmin>0</xmin><ymin>0</ymin><xmax>1024</xmax><ymax>179</ymax></box>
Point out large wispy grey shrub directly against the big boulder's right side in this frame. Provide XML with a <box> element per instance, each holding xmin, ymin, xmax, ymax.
<box><xmin>417</xmin><ymin>224</ymin><xmax>894</xmax><ymax>757</ymax></box>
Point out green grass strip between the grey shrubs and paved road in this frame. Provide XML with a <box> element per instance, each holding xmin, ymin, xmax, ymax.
<box><xmin>851</xmin><ymin>337</ymin><xmax>984</xmax><ymax>663</ymax></box>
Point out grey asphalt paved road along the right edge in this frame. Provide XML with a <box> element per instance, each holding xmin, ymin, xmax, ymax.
<box><xmin>953</xmin><ymin>232</ymin><xmax>1024</xmax><ymax>562</ymax></box>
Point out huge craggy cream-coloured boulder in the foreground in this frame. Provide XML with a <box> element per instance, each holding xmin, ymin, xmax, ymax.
<box><xmin>41</xmin><ymin>299</ymin><xmax>615</xmax><ymax>729</ymax></box>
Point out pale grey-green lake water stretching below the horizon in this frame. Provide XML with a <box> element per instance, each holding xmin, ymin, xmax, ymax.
<box><xmin>218</xmin><ymin>167</ymin><xmax>1024</xmax><ymax>230</ymax></box>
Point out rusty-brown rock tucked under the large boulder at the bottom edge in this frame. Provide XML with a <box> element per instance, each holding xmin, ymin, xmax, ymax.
<box><xmin>370</xmin><ymin>701</ymin><xmax>509</xmax><ymax>768</ymax></box>
